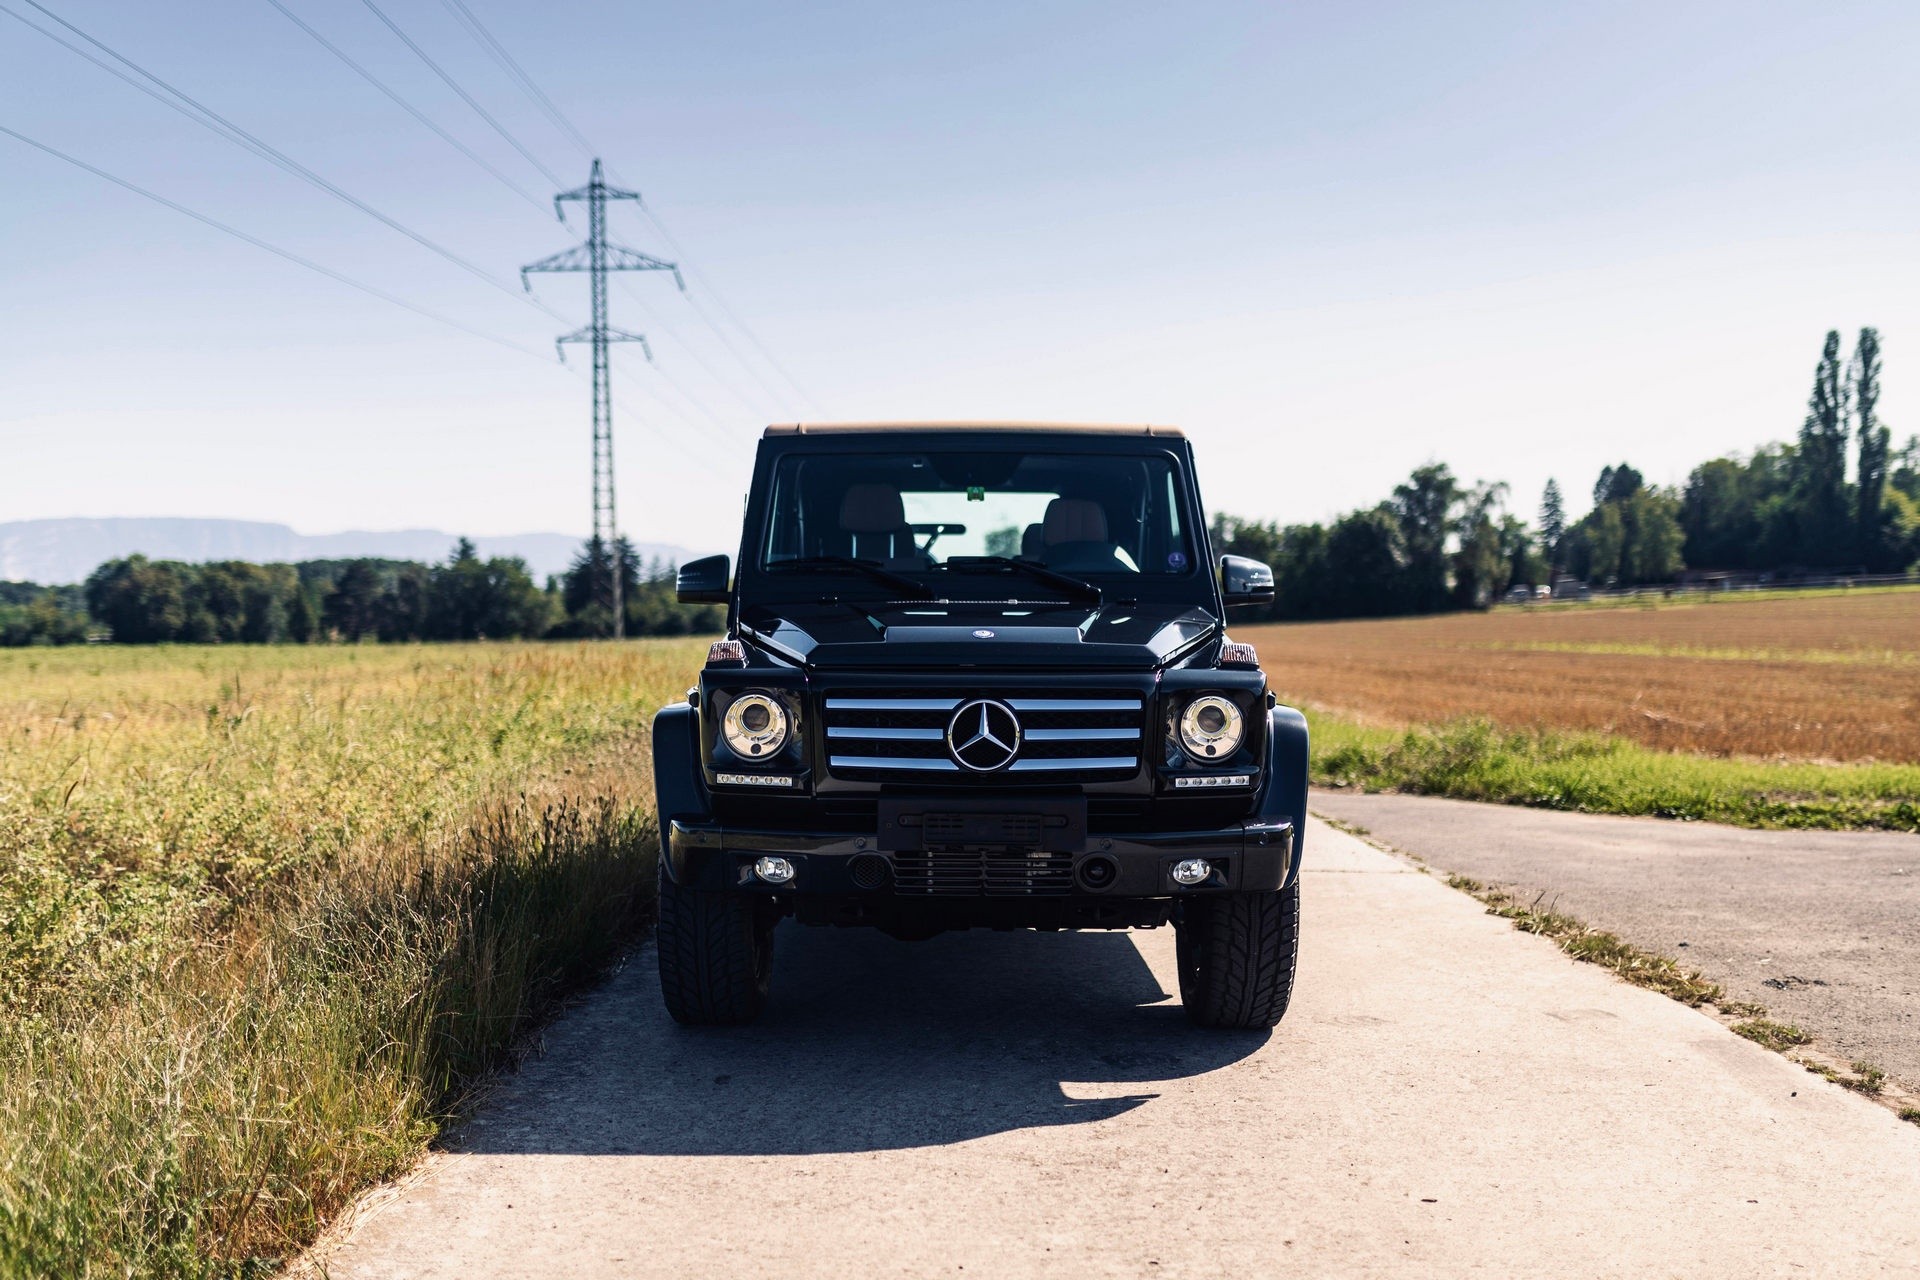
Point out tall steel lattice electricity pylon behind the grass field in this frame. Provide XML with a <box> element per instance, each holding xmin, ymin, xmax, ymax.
<box><xmin>520</xmin><ymin>159</ymin><xmax>687</xmax><ymax>639</ymax></box>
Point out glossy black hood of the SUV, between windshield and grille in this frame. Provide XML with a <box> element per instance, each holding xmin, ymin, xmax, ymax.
<box><xmin>739</xmin><ymin>601</ymin><xmax>1219</xmax><ymax>672</ymax></box>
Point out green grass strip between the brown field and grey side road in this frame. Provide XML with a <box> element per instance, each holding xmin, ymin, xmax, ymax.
<box><xmin>1308</xmin><ymin>712</ymin><xmax>1920</xmax><ymax>831</ymax></box>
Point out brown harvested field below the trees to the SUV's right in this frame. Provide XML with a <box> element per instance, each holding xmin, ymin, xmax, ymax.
<box><xmin>1236</xmin><ymin>589</ymin><xmax>1920</xmax><ymax>764</ymax></box>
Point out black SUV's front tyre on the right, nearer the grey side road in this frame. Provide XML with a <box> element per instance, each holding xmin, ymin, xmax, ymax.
<box><xmin>1173</xmin><ymin>879</ymin><xmax>1300</xmax><ymax>1031</ymax></box>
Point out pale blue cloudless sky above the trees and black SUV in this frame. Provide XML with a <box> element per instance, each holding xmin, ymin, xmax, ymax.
<box><xmin>0</xmin><ymin>0</ymin><xmax>1920</xmax><ymax>547</ymax></box>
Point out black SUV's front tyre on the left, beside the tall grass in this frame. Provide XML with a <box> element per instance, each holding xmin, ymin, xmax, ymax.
<box><xmin>655</xmin><ymin>867</ymin><xmax>776</xmax><ymax>1027</ymax></box>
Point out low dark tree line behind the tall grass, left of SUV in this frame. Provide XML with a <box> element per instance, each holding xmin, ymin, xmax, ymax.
<box><xmin>0</xmin><ymin>537</ymin><xmax>726</xmax><ymax>645</ymax></box>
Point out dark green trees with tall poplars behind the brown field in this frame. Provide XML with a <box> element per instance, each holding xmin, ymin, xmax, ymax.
<box><xmin>1213</xmin><ymin>328</ymin><xmax>1920</xmax><ymax>618</ymax></box>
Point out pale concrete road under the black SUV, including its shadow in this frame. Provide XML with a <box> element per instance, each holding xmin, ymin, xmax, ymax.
<box><xmin>321</xmin><ymin>823</ymin><xmax>1920</xmax><ymax>1280</ymax></box>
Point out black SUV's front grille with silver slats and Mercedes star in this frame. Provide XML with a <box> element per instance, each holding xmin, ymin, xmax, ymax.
<box><xmin>824</xmin><ymin>691</ymin><xmax>1144</xmax><ymax>783</ymax></box>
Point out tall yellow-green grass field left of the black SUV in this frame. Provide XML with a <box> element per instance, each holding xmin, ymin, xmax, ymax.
<box><xmin>0</xmin><ymin>645</ymin><xmax>706</xmax><ymax>1276</ymax></box>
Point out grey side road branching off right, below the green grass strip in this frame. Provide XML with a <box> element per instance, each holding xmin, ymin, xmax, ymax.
<box><xmin>1313</xmin><ymin>791</ymin><xmax>1920</xmax><ymax>1092</ymax></box>
